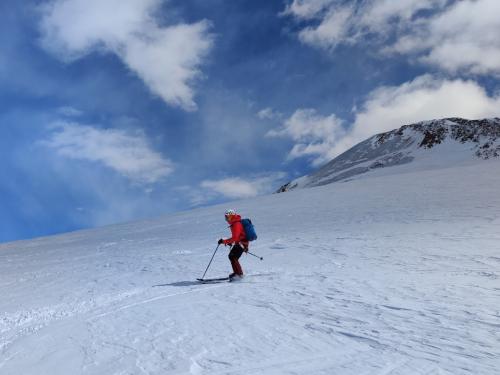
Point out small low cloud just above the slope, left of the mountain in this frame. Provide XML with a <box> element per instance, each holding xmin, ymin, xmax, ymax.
<box><xmin>197</xmin><ymin>172</ymin><xmax>286</xmax><ymax>203</ymax></box>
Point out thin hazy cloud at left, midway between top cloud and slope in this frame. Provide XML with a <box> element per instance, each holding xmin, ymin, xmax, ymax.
<box><xmin>43</xmin><ymin>122</ymin><xmax>173</xmax><ymax>184</ymax></box>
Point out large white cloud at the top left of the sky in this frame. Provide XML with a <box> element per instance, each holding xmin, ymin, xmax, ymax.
<box><xmin>40</xmin><ymin>0</ymin><xmax>213</xmax><ymax>110</ymax></box>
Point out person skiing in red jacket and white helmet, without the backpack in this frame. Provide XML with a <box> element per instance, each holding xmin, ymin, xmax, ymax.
<box><xmin>218</xmin><ymin>210</ymin><xmax>248</xmax><ymax>280</ymax></box>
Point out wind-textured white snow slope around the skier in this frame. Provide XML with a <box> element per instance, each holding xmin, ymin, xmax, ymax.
<box><xmin>0</xmin><ymin>160</ymin><xmax>500</xmax><ymax>375</ymax></box>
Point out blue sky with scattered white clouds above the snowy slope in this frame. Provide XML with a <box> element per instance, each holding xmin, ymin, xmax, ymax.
<box><xmin>0</xmin><ymin>0</ymin><xmax>500</xmax><ymax>242</ymax></box>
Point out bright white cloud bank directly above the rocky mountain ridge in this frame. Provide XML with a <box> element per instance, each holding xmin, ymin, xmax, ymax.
<box><xmin>270</xmin><ymin>75</ymin><xmax>500</xmax><ymax>165</ymax></box>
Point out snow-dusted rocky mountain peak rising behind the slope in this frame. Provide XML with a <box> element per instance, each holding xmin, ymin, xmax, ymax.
<box><xmin>277</xmin><ymin>118</ymin><xmax>500</xmax><ymax>193</ymax></box>
